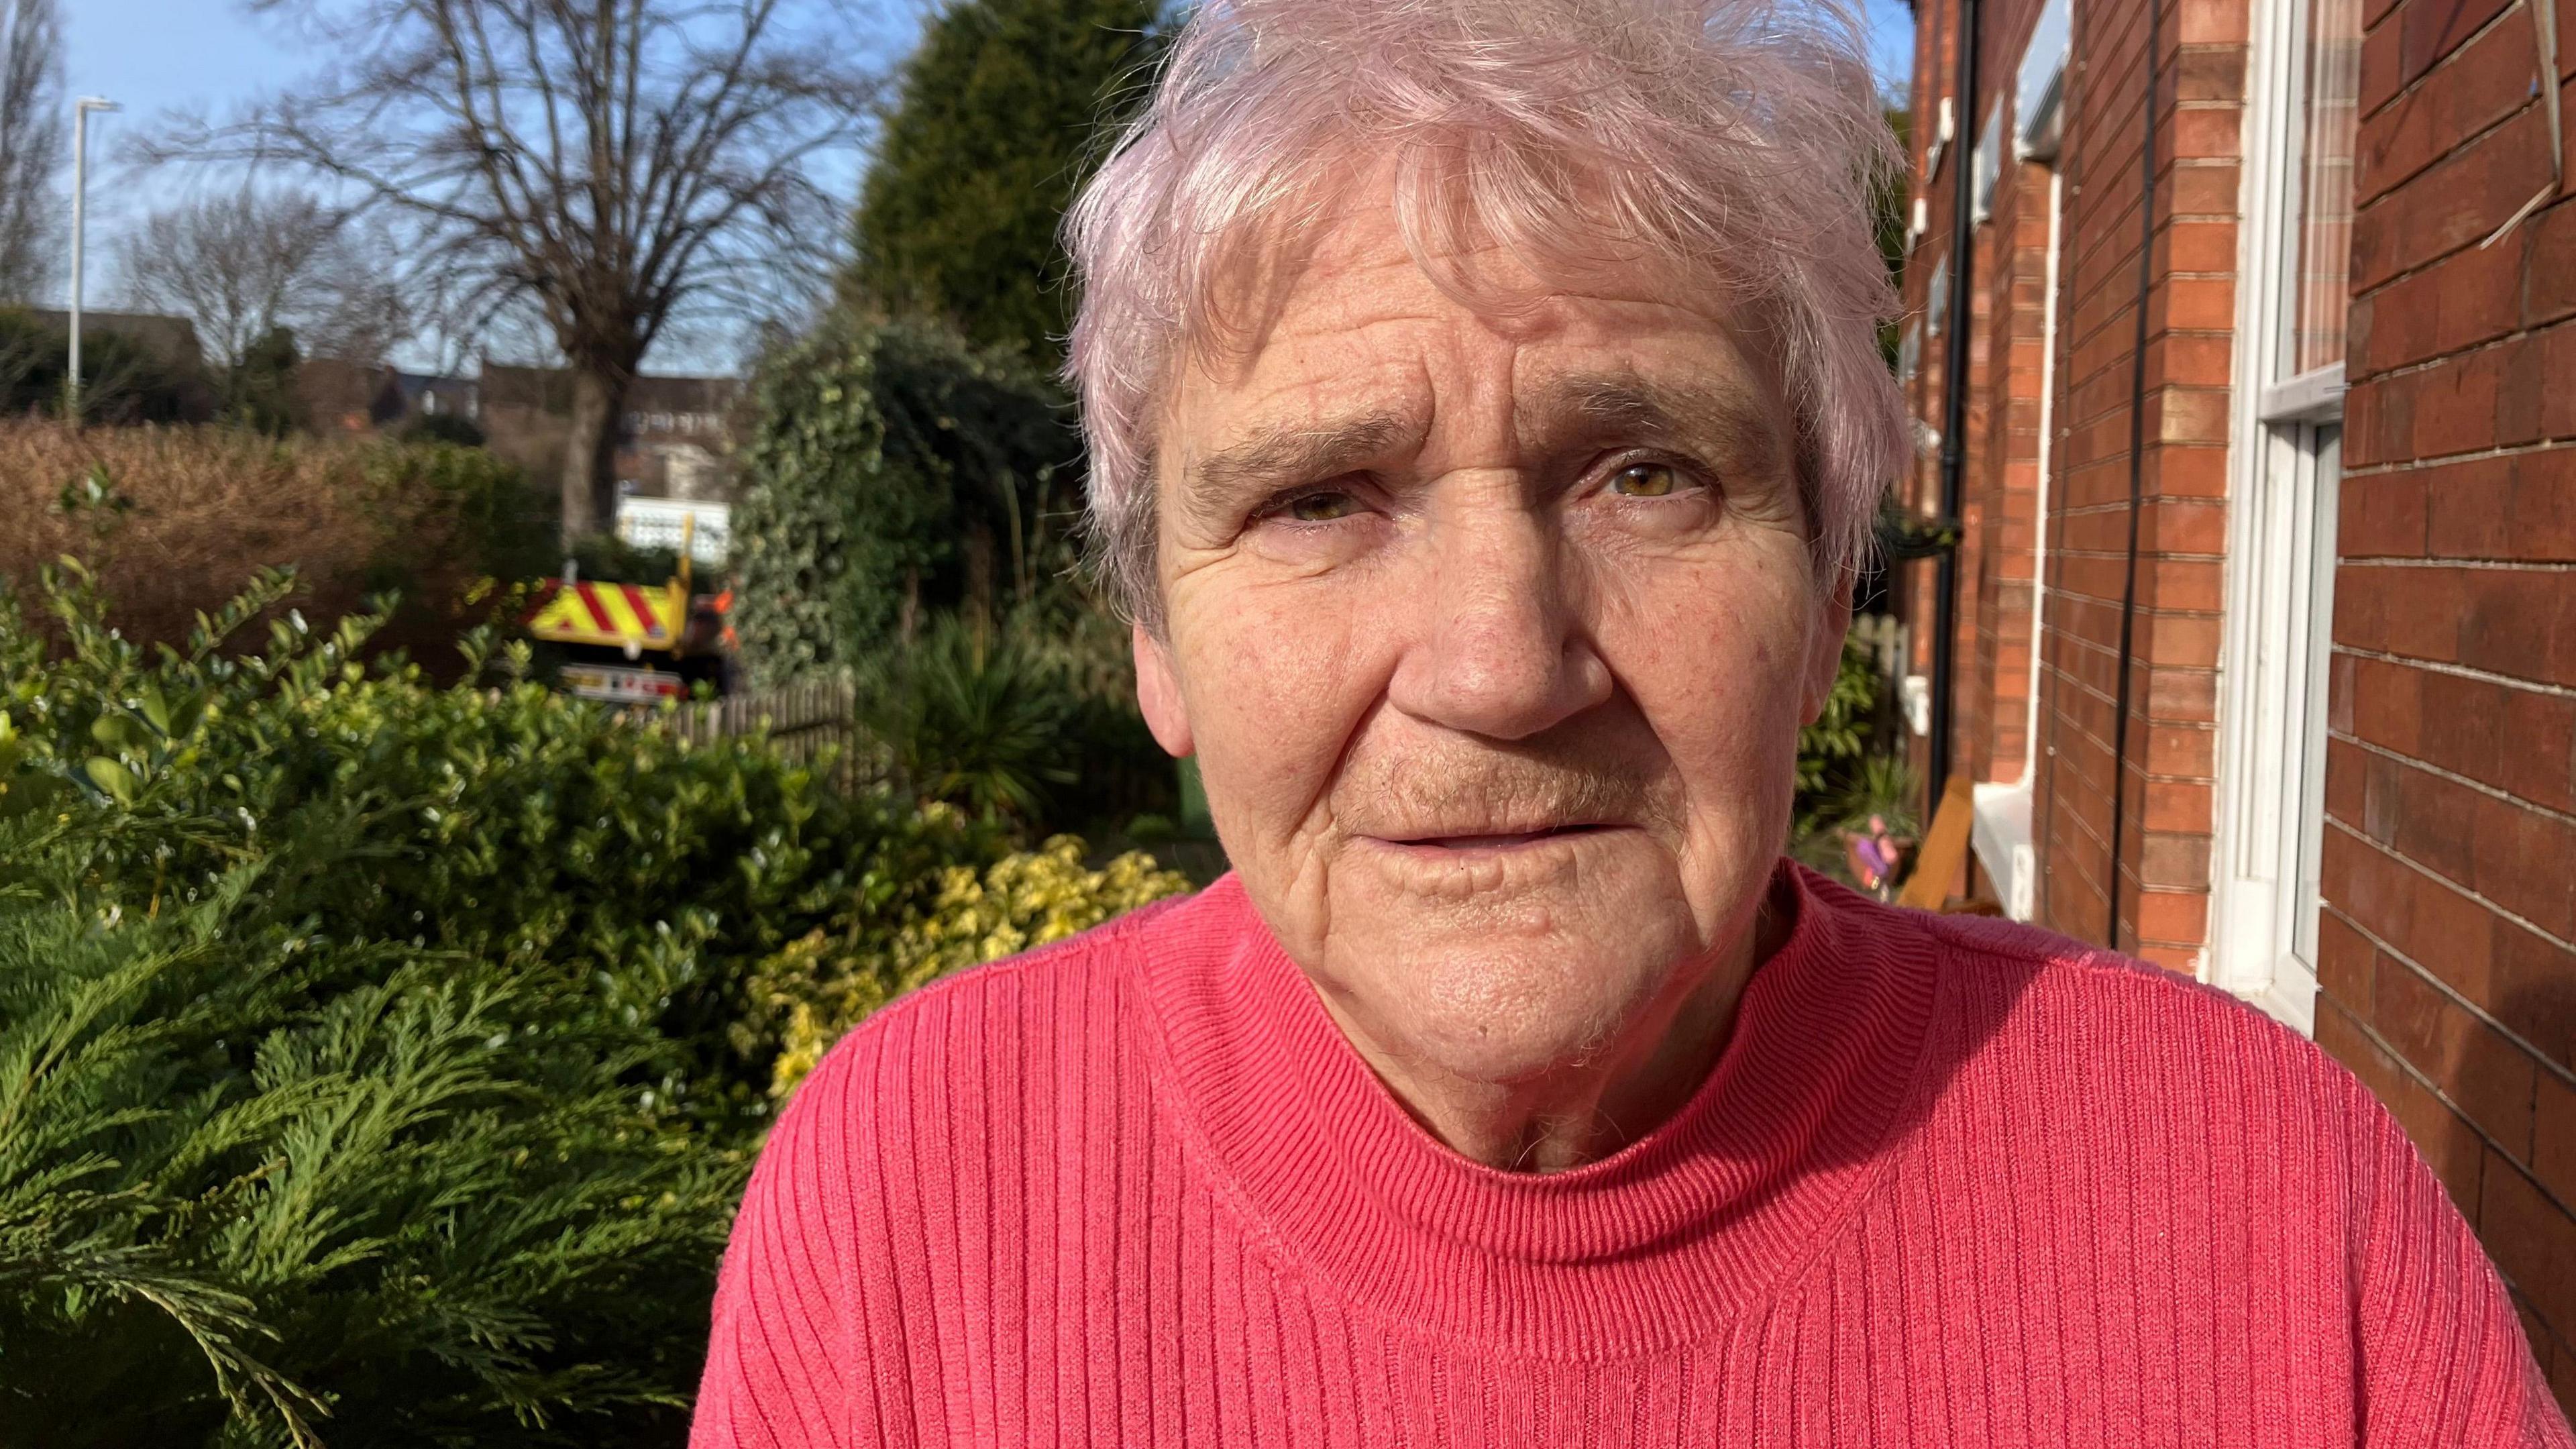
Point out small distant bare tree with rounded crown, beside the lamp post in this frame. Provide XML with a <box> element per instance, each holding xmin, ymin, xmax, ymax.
<box><xmin>116</xmin><ymin>189</ymin><xmax>405</xmax><ymax>374</ymax></box>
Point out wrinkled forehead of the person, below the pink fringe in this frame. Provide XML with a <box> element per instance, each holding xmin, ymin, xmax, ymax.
<box><xmin>1157</xmin><ymin>186</ymin><xmax>1795</xmax><ymax>479</ymax></box>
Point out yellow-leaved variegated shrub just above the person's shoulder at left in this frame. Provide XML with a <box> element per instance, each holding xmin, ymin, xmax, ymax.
<box><xmin>760</xmin><ymin>835</ymin><xmax>1190</xmax><ymax>1095</ymax></box>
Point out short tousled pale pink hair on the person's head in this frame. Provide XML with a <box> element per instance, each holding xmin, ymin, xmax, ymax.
<box><xmin>1064</xmin><ymin>0</ymin><xmax>1909</xmax><ymax>627</ymax></box>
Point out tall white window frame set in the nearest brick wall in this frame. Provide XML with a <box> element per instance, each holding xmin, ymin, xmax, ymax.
<box><xmin>2200</xmin><ymin>0</ymin><xmax>2344</xmax><ymax>1034</ymax></box>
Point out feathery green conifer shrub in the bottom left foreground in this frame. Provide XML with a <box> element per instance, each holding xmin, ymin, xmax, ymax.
<box><xmin>0</xmin><ymin>856</ymin><xmax>749</xmax><ymax>1446</ymax></box>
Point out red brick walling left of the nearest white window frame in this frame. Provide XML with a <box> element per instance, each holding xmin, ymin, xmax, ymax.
<box><xmin>1907</xmin><ymin>0</ymin><xmax>2249</xmax><ymax>949</ymax></box>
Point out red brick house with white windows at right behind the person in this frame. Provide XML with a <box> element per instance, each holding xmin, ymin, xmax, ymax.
<box><xmin>1898</xmin><ymin>0</ymin><xmax>2576</xmax><ymax>1403</ymax></box>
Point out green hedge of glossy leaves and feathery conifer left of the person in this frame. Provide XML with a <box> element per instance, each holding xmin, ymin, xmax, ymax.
<box><xmin>0</xmin><ymin>561</ymin><xmax>1061</xmax><ymax>1444</ymax></box>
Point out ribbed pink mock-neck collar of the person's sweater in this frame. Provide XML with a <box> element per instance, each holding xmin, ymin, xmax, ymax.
<box><xmin>1138</xmin><ymin>861</ymin><xmax>1935</xmax><ymax>1358</ymax></box>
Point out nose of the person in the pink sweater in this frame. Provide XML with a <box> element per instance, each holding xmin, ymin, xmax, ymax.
<box><xmin>1389</xmin><ymin>511</ymin><xmax>1613</xmax><ymax>740</ymax></box>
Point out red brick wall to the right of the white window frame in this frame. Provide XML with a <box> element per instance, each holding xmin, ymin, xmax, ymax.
<box><xmin>2316</xmin><ymin>0</ymin><xmax>2576</xmax><ymax>1403</ymax></box>
